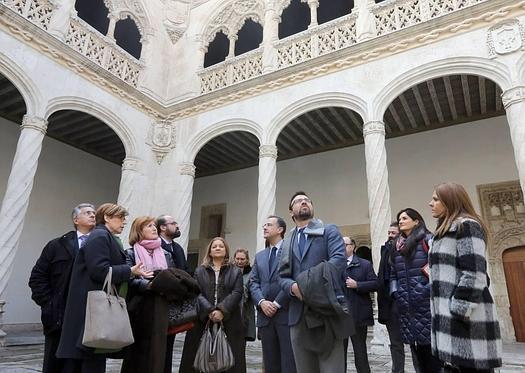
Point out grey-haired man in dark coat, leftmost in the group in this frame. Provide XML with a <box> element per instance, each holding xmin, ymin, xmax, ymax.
<box><xmin>29</xmin><ymin>203</ymin><xmax>95</xmax><ymax>373</ymax></box>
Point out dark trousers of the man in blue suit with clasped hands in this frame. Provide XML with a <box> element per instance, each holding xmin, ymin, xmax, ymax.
<box><xmin>259</xmin><ymin>320</ymin><xmax>296</xmax><ymax>373</ymax></box>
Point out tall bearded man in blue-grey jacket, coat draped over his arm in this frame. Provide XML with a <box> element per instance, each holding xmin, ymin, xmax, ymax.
<box><xmin>279</xmin><ymin>192</ymin><xmax>346</xmax><ymax>373</ymax></box>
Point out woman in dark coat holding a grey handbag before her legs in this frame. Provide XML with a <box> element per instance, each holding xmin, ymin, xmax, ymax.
<box><xmin>179</xmin><ymin>237</ymin><xmax>246</xmax><ymax>373</ymax></box>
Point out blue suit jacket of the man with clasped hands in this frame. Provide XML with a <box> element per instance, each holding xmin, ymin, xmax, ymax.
<box><xmin>250</xmin><ymin>247</ymin><xmax>290</xmax><ymax>327</ymax></box>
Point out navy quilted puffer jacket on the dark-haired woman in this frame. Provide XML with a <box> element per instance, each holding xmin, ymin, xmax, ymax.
<box><xmin>390</xmin><ymin>231</ymin><xmax>432</xmax><ymax>345</ymax></box>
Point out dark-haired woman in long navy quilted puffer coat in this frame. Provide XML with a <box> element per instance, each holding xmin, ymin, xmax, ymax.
<box><xmin>390</xmin><ymin>208</ymin><xmax>441</xmax><ymax>373</ymax></box>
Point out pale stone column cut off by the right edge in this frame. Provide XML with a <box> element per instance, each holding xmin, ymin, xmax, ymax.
<box><xmin>501</xmin><ymin>86</ymin><xmax>525</xmax><ymax>192</ymax></box>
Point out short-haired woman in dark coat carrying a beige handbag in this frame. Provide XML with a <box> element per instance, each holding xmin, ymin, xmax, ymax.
<box><xmin>57</xmin><ymin>203</ymin><xmax>151</xmax><ymax>373</ymax></box>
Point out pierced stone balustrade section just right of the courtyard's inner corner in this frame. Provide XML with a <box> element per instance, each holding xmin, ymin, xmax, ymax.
<box><xmin>199</xmin><ymin>48</ymin><xmax>262</xmax><ymax>94</ymax></box>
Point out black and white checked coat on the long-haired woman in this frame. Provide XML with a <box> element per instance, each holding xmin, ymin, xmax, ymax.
<box><xmin>429</xmin><ymin>219</ymin><xmax>501</xmax><ymax>369</ymax></box>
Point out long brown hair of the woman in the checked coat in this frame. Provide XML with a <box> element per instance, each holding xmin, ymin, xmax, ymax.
<box><xmin>434</xmin><ymin>182</ymin><xmax>489</xmax><ymax>242</ymax></box>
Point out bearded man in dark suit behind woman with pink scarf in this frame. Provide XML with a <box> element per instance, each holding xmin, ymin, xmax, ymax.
<box><xmin>155</xmin><ymin>215</ymin><xmax>188</xmax><ymax>373</ymax></box>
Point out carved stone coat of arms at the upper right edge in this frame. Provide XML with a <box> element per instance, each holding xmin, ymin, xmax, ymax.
<box><xmin>487</xmin><ymin>19</ymin><xmax>525</xmax><ymax>58</ymax></box>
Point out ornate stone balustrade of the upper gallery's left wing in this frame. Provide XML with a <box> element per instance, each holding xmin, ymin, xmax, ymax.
<box><xmin>0</xmin><ymin>0</ymin><xmax>143</xmax><ymax>87</ymax></box>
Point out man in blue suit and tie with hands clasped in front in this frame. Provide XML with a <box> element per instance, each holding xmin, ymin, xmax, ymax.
<box><xmin>250</xmin><ymin>215</ymin><xmax>296</xmax><ymax>373</ymax></box>
